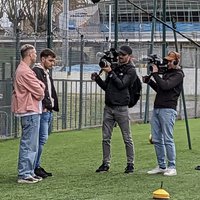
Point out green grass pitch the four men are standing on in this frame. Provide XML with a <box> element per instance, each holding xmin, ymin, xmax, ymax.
<box><xmin>0</xmin><ymin>119</ymin><xmax>200</xmax><ymax>200</ymax></box>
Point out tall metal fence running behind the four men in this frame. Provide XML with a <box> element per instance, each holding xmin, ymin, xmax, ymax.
<box><xmin>0</xmin><ymin>38</ymin><xmax>200</xmax><ymax>138</ymax></box>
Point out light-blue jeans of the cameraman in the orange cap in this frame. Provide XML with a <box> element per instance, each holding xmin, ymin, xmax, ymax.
<box><xmin>151</xmin><ymin>108</ymin><xmax>177</xmax><ymax>169</ymax></box>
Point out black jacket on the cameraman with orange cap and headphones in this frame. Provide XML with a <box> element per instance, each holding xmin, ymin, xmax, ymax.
<box><xmin>148</xmin><ymin>69</ymin><xmax>184</xmax><ymax>110</ymax></box>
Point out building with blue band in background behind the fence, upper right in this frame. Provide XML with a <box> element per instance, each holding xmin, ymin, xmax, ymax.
<box><xmin>65</xmin><ymin>0</ymin><xmax>200</xmax><ymax>41</ymax></box>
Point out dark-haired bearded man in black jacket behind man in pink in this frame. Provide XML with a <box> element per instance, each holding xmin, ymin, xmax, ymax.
<box><xmin>33</xmin><ymin>49</ymin><xmax>59</xmax><ymax>178</ymax></box>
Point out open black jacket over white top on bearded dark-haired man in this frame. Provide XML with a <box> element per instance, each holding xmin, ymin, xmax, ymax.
<box><xmin>33</xmin><ymin>66</ymin><xmax>59</xmax><ymax>112</ymax></box>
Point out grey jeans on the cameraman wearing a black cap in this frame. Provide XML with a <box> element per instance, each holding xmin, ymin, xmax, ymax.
<box><xmin>102</xmin><ymin>106</ymin><xmax>134</xmax><ymax>164</ymax></box>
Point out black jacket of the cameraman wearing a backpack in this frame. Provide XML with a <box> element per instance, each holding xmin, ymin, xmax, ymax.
<box><xmin>95</xmin><ymin>63</ymin><xmax>136</xmax><ymax>106</ymax></box>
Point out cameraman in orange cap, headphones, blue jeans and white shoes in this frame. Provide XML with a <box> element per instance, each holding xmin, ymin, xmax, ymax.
<box><xmin>143</xmin><ymin>51</ymin><xmax>184</xmax><ymax>176</ymax></box>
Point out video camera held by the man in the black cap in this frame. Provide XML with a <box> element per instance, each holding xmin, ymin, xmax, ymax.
<box><xmin>96</xmin><ymin>48</ymin><xmax>119</xmax><ymax>69</ymax></box>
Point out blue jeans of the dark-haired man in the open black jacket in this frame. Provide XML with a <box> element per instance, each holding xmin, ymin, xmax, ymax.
<box><xmin>35</xmin><ymin>112</ymin><xmax>53</xmax><ymax>168</ymax></box>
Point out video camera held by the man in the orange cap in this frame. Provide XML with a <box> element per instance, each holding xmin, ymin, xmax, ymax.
<box><xmin>143</xmin><ymin>54</ymin><xmax>168</xmax><ymax>74</ymax></box>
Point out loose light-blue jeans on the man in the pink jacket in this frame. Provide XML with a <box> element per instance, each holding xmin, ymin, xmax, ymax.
<box><xmin>18</xmin><ymin>114</ymin><xmax>40</xmax><ymax>178</ymax></box>
